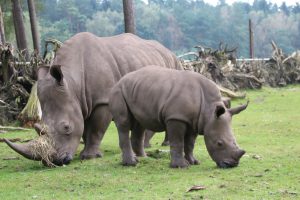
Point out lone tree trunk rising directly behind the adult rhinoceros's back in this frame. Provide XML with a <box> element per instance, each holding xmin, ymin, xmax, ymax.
<box><xmin>123</xmin><ymin>0</ymin><xmax>135</xmax><ymax>34</ymax></box>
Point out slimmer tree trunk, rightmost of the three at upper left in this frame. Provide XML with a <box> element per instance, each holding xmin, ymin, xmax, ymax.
<box><xmin>27</xmin><ymin>0</ymin><xmax>40</xmax><ymax>54</ymax></box>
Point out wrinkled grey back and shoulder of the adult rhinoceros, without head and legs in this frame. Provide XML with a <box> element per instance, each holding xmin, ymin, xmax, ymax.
<box><xmin>53</xmin><ymin>33</ymin><xmax>183</xmax><ymax>118</ymax></box>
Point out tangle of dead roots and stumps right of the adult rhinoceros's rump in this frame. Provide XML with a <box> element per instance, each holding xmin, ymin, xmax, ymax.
<box><xmin>179</xmin><ymin>41</ymin><xmax>300</xmax><ymax>91</ymax></box>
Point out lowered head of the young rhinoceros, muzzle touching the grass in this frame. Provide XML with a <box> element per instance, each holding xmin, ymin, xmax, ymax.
<box><xmin>204</xmin><ymin>102</ymin><xmax>248</xmax><ymax>168</ymax></box>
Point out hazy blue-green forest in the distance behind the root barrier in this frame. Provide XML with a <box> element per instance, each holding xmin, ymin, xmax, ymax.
<box><xmin>0</xmin><ymin>0</ymin><xmax>300</xmax><ymax>58</ymax></box>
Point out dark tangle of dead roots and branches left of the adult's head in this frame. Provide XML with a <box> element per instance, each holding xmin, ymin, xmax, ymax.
<box><xmin>0</xmin><ymin>44</ymin><xmax>38</xmax><ymax>124</ymax></box>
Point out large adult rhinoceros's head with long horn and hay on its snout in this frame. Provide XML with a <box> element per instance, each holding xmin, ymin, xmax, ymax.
<box><xmin>6</xmin><ymin>65</ymin><xmax>84</xmax><ymax>165</ymax></box>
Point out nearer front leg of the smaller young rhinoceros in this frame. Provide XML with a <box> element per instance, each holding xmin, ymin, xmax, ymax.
<box><xmin>167</xmin><ymin>120</ymin><xmax>189</xmax><ymax>168</ymax></box>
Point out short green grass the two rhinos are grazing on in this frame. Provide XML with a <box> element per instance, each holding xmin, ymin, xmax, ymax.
<box><xmin>0</xmin><ymin>85</ymin><xmax>300</xmax><ymax>199</ymax></box>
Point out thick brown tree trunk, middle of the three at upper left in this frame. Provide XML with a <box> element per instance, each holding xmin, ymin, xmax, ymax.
<box><xmin>12</xmin><ymin>0</ymin><xmax>29</xmax><ymax>60</ymax></box>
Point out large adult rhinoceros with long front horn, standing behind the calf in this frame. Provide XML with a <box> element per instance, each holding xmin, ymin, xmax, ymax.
<box><xmin>6</xmin><ymin>33</ymin><xmax>183</xmax><ymax>165</ymax></box>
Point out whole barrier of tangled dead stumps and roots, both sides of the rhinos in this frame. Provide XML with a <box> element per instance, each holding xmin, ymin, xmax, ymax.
<box><xmin>0</xmin><ymin>39</ymin><xmax>300</xmax><ymax>125</ymax></box>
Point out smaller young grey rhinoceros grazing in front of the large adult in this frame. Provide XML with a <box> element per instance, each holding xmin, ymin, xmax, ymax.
<box><xmin>109</xmin><ymin>66</ymin><xmax>247</xmax><ymax>168</ymax></box>
